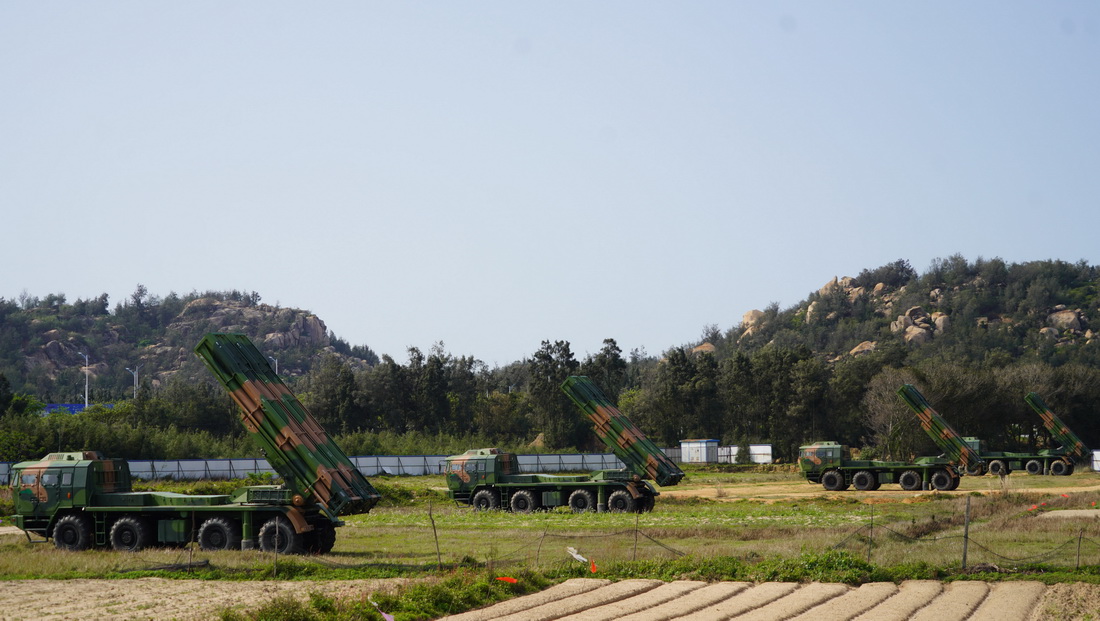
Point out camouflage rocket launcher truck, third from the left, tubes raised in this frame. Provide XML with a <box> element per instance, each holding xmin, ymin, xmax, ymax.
<box><xmin>799</xmin><ymin>384</ymin><xmax>982</xmax><ymax>491</ymax></box>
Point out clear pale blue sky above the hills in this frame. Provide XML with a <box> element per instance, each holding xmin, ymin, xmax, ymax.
<box><xmin>0</xmin><ymin>0</ymin><xmax>1100</xmax><ymax>367</ymax></box>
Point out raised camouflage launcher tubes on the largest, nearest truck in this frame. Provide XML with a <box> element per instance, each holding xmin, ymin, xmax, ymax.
<box><xmin>195</xmin><ymin>333</ymin><xmax>381</xmax><ymax>520</ymax></box>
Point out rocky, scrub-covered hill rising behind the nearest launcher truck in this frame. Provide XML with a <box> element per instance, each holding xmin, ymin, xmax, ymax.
<box><xmin>0</xmin><ymin>296</ymin><xmax>377</xmax><ymax>401</ymax></box>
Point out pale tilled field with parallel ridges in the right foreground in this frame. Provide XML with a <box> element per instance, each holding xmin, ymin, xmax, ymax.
<box><xmin>444</xmin><ymin>578</ymin><xmax>1082</xmax><ymax>621</ymax></box>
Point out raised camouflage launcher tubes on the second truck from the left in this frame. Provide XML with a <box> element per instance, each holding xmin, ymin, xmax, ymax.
<box><xmin>561</xmin><ymin>375</ymin><xmax>684</xmax><ymax>486</ymax></box>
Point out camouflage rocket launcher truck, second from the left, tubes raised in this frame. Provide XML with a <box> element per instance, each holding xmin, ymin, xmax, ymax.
<box><xmin>444</xmin><ymin>376</ymin><xmax>684</xmax><ymax>513</ymax></box>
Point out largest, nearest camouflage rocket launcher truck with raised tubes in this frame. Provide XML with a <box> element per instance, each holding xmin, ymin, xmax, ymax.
<box><xmin>11</xmin><ymin>334</ymin><xmax>380</xmax><ymax>554</ymax></box>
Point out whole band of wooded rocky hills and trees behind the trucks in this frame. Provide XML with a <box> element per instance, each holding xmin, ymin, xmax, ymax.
<box><xmin>0</xmin><ymin>255</ymin><xmax>1100</xmax><ymax>461</ymax></box>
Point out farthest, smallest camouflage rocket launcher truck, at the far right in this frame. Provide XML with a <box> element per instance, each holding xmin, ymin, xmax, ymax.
<box><xmin>963</xmin><ymin>392</ymin><xmax>1091</xmax><ymax>476</ymax></box>
